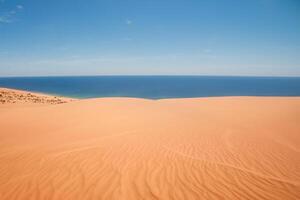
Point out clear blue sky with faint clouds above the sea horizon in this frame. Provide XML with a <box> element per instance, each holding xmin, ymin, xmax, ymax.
<box><xmin>0</xmin><ymin>0</ymin><xmax>300</xmax><ymax>76</ymax></box>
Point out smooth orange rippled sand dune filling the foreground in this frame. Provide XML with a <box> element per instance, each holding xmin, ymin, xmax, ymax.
<box><xmin>0</xmin><ymin>90</ymin><xmax>300</xmax><ymax>200</ymax></box>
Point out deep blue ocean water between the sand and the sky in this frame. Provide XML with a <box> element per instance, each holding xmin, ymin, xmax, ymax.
<box><xmin>0</xmin><ymin>76</ymin><xmax>300</xmax><ymax>99</ymax></box>
